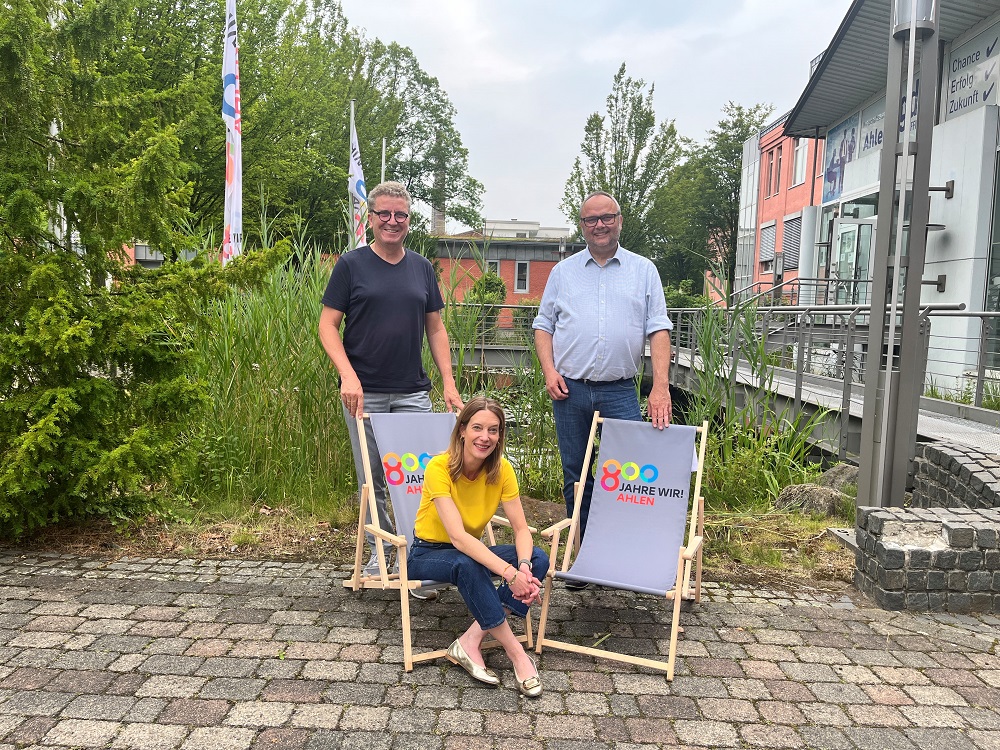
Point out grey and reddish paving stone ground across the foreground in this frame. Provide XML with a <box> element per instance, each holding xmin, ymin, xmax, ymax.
<box><xmin>0</xmin><ymin>550</ymin><xmax>1000</xmax><ymax>750</ymax></box>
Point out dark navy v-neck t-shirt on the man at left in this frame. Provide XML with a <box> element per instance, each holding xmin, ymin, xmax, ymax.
<box><xmin>323</xmin><ymin>250</ymin><xmax>444</xmax><ymax>393</ymax></box>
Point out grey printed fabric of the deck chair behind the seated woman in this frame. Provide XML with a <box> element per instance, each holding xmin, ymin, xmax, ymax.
<box><xmin>369</xmin><ymin>412</ymin><xmax>455</xmax><ymax>542</ymax></box>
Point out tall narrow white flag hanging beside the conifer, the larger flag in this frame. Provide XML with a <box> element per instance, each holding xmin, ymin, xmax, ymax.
<box><xmin>222</xmin><ymin>0</ymin><xmax>243</xmax><ymax>265</ymax></box>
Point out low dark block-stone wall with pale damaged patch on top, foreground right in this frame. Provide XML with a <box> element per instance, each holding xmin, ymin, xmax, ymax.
<box><xmin>854</xmin><ymin>508</ymin><xmax>1000</xmax><ymax>614</ymax></box>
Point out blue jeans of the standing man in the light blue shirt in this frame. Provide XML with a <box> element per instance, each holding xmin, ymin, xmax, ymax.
<box><xmin>552</xmin><ymin>378</ymin><xmax>642</xmax><ymax>539</ymax></box>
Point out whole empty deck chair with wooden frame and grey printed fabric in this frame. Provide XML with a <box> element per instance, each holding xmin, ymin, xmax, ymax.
<box><xmin>535</xmin><ymin>414</ymin><xmax>708</xmax><ymax>680</ymax></box>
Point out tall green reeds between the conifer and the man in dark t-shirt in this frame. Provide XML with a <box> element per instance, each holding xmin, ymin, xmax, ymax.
<box><xmin>187</xmin><ymin>245</ymin><xmax>356</xmax><ymax>522</ymax></box>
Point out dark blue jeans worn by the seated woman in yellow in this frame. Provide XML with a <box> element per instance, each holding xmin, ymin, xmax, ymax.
<box><xmin>406</xmin><ymin>538</ymin><xmax>549</xmax><ymax>630</ymax></box>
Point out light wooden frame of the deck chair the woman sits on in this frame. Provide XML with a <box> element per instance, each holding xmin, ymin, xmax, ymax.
<box><xmin>344</xmin><ymin>414</ymin><xmax>537</xmax><ymax>672</ymax></box>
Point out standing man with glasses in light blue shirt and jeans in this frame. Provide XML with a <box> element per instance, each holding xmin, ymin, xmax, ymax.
<box><xmin>532</xmin><ymin>191</ymin><xmax>673</xmax><ymax>584</ymax></box>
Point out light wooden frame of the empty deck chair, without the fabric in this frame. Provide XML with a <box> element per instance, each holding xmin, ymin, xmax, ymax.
<box><xmin>535</xmin><ymin>413</ymin><xmax>708</xmax><ymax>680</ymax></box>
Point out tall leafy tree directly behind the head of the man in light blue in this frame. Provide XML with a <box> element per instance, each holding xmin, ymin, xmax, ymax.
<box><xmin>561</xmin><ymin>63</ymin><xmax>684</xmax><ymax>257</ymax></box>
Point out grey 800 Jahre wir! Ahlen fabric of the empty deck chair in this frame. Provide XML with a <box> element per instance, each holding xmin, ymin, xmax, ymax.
<box><xmin>559</xmin><ymin>419</ymin><xmax>697</xmax><ymax>595</ymax></box>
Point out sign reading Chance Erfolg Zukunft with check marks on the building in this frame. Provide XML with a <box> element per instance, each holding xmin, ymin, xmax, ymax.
<box><xmin>942</xmin><ymin>24</ymin><xmax>1000</xmax><ymax>120</ymax></box>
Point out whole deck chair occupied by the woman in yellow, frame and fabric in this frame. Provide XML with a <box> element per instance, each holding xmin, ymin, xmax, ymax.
<box><xmin>344</xmin><ymin>412</ymin><xmax>536</xmax><ymax>672</ymax></box>
